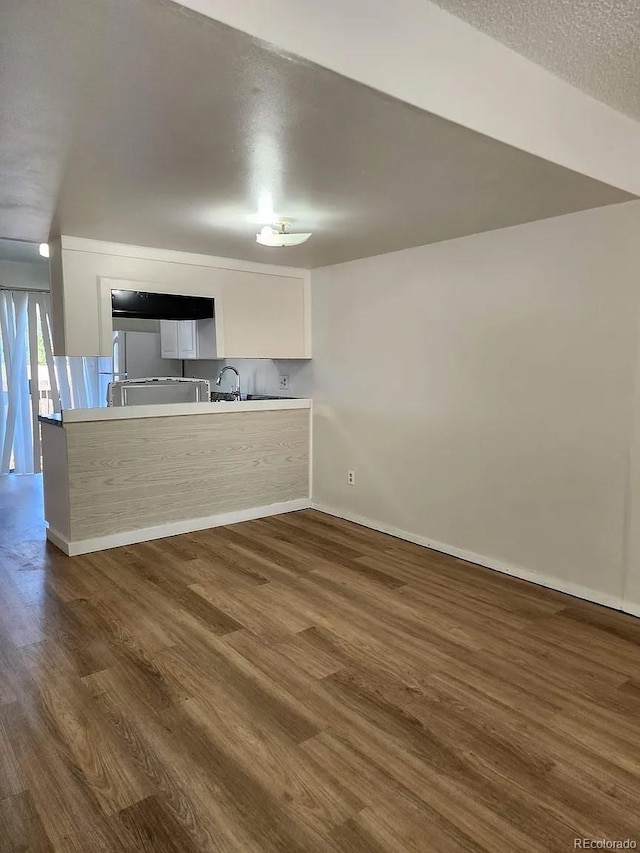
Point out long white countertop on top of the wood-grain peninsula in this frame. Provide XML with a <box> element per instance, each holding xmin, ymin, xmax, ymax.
<box><xmin>41</xmin><ymin>398</ymin><xmax>311</xmax><ymax>426</ymax></box>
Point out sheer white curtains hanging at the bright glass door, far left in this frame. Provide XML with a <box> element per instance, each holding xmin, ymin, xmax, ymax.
<box><xmin>0</xmin><ymin>289</ymin><xmax>112</xmax><ymax>475</ymax></box>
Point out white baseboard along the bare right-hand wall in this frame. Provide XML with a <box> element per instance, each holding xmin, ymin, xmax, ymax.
<box><xmin>311</xmin><ymin>501</ymin><xmax>640</xmax><ymax>617</ymax></box>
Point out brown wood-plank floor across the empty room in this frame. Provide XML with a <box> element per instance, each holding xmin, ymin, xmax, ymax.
<box><xmin>0</xmin><ymin>478</ymin><xmax>640</xmax><ymax>853</ymax></box>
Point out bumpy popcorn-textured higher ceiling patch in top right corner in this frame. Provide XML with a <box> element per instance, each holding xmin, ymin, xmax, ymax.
<box><xmin>434</xmin><ymin>0</ymin><xmax>640</xmax><ymax>120</ymax></box>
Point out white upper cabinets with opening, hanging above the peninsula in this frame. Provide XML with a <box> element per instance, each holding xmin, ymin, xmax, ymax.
<box><xmin>50</xmin><ymin>237</ymin><xmax>311</xmax><ymax>359</ymax></box>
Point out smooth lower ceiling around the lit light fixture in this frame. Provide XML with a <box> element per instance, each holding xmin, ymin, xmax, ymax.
<box><xmin>0</xmin><ymin>0</ymin><xmax>631</xmax><ymax>267</ymax></box>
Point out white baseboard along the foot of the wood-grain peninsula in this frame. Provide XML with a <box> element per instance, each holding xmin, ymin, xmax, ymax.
<box><xmin>47</xmin><ymin>498</ymin><xmax>311</xmax><ymax>557</ymax></box>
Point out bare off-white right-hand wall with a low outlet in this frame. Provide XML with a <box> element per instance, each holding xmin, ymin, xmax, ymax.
<box><xmin>312</xmin><ymin>202</ymin><xmax>640</xmax><ymax>604</ymax></box>
